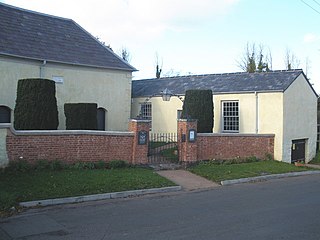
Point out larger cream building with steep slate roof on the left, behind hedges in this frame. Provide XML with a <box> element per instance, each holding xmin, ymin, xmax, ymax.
<box><xmin>0</xmin><ymin>3</ymin><xmax>136</xmax><ymax>130</ymax></box>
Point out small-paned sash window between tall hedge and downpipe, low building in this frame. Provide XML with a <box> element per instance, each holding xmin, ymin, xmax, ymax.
<box><xmin>222</xmin><ymin>101</ymin><xmax>239</xmax><ymax>132</ymax></box>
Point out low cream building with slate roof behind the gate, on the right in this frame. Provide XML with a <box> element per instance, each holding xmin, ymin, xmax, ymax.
<box><xmin>131</xmin><ymin>70</ymin><xmax>318</xmax><ymax>163</ymax></box>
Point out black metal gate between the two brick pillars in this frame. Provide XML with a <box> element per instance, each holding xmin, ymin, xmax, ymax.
<box><xmin>148</xmin><ymin>133</ymin><xmax>179</xmax><ymax>163</ymax></box>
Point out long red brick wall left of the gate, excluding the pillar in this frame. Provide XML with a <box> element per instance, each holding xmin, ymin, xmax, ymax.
<box><xmin>7</xmin><ymin>133</ymin><xmax>133</xmax><ymax>163</ymax></box>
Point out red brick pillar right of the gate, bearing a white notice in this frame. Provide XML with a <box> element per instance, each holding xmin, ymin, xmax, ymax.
<box><xmin>178</xmin><ymin>119</ymin><xmax>198</xmax><ymax>162</ymax></box>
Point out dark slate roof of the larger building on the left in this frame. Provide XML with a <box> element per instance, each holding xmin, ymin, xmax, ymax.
<box><xmin>0</xmin><ymin>3</ymin><xmax>136</xmax><ymax>71</ymax></box>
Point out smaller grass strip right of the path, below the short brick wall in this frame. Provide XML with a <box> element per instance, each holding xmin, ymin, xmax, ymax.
<box><xmin>188</xmin><ymin>160</ymin><xmax>310</xmax><ymax>182</ymax></box>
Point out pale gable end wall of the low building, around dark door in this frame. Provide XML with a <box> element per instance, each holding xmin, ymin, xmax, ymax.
<box><xmin>283</xmin><ymin>74</ymin><xmax>317</xmax><ymax>162</ymax></box>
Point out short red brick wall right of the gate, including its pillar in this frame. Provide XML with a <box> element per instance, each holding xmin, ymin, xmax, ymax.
<box><xmin>178</xmin><ymin>119</ymin><xmax>274</xmax><ymax>162</ymax></box>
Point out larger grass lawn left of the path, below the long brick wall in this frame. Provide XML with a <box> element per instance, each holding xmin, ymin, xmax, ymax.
<box><xmin>0</xmin><ymin>168</ymin><xmax>175</xmax><ymax>211</ymax></box>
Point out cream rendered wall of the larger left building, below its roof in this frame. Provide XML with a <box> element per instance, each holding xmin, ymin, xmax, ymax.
<box><xmin>0</xmin><ymin>57</ymin><xmax>132</xmax><ymax>130</ymax></box>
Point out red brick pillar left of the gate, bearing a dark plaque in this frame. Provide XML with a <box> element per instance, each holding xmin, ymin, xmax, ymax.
<box><xmin>129</xmin><ymin>119</ymin><xmax>151</xmax><ymax>164</ymax></box>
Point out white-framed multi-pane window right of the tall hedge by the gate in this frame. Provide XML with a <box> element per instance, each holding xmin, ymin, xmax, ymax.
<box><xmin>221</xmin><ymin>100</ymin><xmax>240</xmax><ymax>133</ymax></box>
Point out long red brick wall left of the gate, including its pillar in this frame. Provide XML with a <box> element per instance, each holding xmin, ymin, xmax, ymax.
<box><xmin>2</xmin><ymin>120</ymin><xmax>150</xmax><ymax>164</ymax></box>
